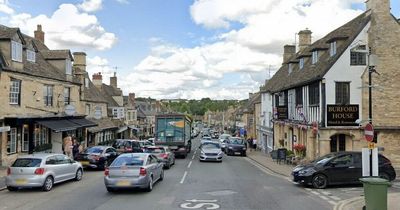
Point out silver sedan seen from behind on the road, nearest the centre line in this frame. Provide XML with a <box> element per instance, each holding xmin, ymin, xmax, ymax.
<box><xmin>104</xmin><ymin>153</ymin><xmax>164</xmax><ymax>192</ymax></box>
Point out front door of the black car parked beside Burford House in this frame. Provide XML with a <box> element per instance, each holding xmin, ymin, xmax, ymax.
<box><xmin>325</xmin><ymin>154</ymin><xmax>353</xmax><ymax>183</ymax></box>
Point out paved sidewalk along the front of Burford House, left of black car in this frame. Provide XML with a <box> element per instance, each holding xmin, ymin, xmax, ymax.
<box><xmin>247</xmin><ymin>151</ymin><xmax>294</xmax><ymax>178</ymax></box>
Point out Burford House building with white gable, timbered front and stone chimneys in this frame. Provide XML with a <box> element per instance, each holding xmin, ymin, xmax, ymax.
<box><xmin>265</xmin><ymin>0</ymin><xmax>400</xmax><ymax>167</ymax></box>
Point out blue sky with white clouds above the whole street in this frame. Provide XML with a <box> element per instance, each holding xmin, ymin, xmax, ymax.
<box><xmin>0</xmin><ymin>0</ymin><xmax>400</xmax><ymax>100</ymax></box>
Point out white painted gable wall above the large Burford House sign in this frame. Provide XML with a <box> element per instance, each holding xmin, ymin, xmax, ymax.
<box><xmin>324</xmin><ymin>23</ymin><xmax>370</xmax><ymax>122</ymax></box>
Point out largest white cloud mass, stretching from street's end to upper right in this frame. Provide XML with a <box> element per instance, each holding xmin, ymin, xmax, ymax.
<box><xmin>120</xmin><ymin>0</ymin><xmax>363</xmax><ymax>99</ymax></box>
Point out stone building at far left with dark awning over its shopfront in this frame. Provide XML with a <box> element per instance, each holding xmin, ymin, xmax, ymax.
<box><xmin>0</xmin><ymin>25</ymin><xmax>95</xmax><ymax>165</ymax></box>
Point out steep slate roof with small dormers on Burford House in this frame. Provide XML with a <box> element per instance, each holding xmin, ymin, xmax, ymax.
<box><xmin>262</xmin><ymin>12</ymin><xmax>371</xmax><ymax>93</ymax></box>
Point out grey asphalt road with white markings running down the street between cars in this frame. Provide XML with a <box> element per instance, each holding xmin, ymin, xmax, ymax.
<box><xmin>0</xmin><ymin>138</ymin><xmax>332</xmax><ymax>210</ymax></box>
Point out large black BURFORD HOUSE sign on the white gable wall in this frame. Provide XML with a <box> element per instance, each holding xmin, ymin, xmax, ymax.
<box><xmin>327</xmin><ymin>104</ymin><xmax>359</xmax><ymax>126</ymax></box>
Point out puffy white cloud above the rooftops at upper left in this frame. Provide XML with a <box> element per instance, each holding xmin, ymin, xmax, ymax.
<box><xmin>1</xmin><ymin>4</ymin><xmax>117</xmax><ymax>50</ymax></box>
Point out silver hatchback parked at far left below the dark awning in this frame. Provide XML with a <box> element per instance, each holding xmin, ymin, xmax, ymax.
<box><xmin>6</xmin><ymin>153</ymin><xmax>83</xmax><ymax>191</ymax></box>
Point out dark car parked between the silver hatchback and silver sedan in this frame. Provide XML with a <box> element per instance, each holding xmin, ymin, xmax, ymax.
<box><xmin>75</xmin><ymin>146</ymin><xmax>118</xmax><ymax>169</ymax></box>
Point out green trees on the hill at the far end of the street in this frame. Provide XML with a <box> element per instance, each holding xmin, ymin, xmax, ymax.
<box><xmin>167</xmin><ymin>98</ymin><xmax>241</xmax><ymax>115</ymax></box>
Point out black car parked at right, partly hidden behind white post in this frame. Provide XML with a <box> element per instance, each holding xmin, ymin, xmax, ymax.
<box><xmin>292</xmin><ymin>152</ymin><xmax>396</xmax><ymax>189</ymax></box>
